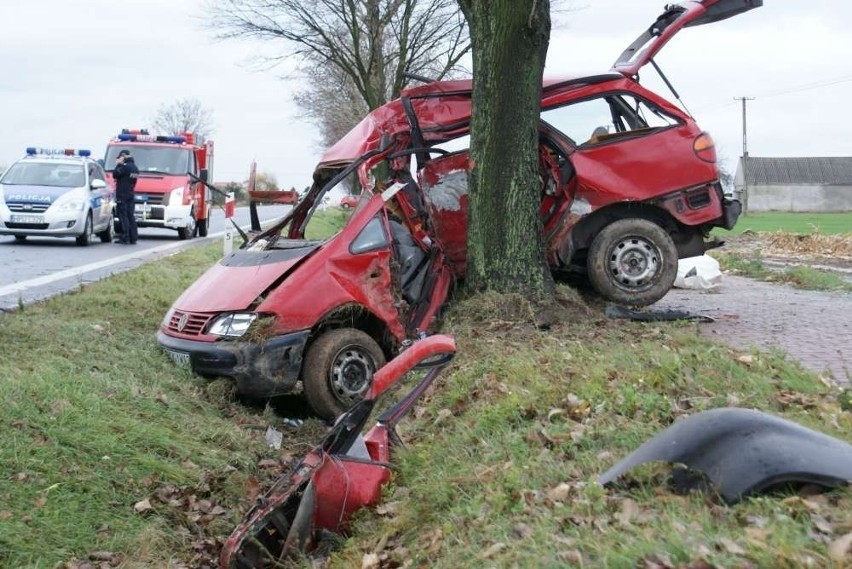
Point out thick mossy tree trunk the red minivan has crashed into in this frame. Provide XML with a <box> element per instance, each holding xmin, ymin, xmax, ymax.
<box><xmin>459</xmin><ymin>0</ymin><xmax>554</xmax><ymax>299</ymax></box>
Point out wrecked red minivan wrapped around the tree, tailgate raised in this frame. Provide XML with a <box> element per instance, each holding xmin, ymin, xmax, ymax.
<box><xmin>158</xmin><ymin>0</ymin><xmax>762</xmax><ymax>417</ymax></box>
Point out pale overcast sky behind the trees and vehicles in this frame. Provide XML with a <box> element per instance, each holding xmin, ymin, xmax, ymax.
<box><xmin>0</xmin><ymin>0</ymin><xmax>852</xmax><ymax>188</ymax></box>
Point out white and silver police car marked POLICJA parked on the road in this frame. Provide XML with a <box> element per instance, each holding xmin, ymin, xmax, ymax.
<box><xmin>0</xmin><ymin>147</ymin><xmax>115</xmax><ymax>246</ymax></box>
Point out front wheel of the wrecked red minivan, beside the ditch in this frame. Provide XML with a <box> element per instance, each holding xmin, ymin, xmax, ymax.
<box><xmin>302</xmin><ymin>328</ymin><xmax>385</xmax><ymax>420</ymax></box>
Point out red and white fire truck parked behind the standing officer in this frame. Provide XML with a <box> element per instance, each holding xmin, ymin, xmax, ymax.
<box><xmin>104</xmin><ymin>129</ymin><xmax>213</xmax><ymax>239</ymax></box>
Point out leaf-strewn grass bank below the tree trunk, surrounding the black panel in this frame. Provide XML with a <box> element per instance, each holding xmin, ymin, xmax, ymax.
<box><xmin>329</xmin><ymin>293</ymin><xmax>852</xmax><ymax>569</ymax></box>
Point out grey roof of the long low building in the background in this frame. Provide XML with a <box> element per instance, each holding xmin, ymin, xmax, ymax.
<box><xmin>740</xmin><ymin>156</ymin><xmax>852</xmax><ymax>186</ymax></box>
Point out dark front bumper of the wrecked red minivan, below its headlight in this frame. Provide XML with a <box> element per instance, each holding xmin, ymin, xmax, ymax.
<box><xmin>157</xmin><ymin>330</ymin><xmax>310</xmax><ymax>397</ymax></box>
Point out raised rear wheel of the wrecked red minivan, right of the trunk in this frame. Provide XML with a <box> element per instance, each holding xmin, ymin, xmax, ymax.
<box><xmin>587</xmin><ymin>218</ymin><xmax>677</xmax><ymax>306</ymax></box>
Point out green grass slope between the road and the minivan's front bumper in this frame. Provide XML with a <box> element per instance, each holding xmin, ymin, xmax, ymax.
<box><xmin>0</xmin><ymin>245</ymin><xmax>322</xmax><ymax>568</ymax></box>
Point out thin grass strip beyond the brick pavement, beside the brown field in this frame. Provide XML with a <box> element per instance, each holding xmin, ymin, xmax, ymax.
<box><xmin>710</xmin><ymin>251</ymin><xmax>852</xmax><ymax>292</ymax></box>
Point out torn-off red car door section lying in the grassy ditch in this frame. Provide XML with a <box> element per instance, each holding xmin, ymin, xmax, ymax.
<box><xmin>219</xmin><ymin>335</ymin><xmax>455</xmax><ymax>569</ymax></box>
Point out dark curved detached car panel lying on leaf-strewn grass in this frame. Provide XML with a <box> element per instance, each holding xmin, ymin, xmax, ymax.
<box><xmin>598</xmin><ymin>408</ymin><xmax>852</xmax><ymax>504</ymax></box>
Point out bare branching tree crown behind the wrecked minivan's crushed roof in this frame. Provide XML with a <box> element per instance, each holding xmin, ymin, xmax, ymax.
<box><xmin>206</xmin><ymin>0</ymin><xmax>470</xmax><ymax>140</ymax></box>
